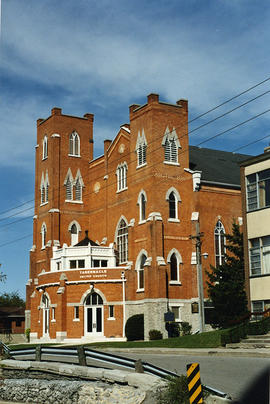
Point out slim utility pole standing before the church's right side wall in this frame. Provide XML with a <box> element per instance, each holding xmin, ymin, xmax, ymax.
<box><xmin>190</xmin><ymin>212</ymin><xmax>205</xmax><ymax>332</ymax></box>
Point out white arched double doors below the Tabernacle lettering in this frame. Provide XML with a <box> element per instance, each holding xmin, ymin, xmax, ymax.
<box><xmin>84</xmin><ymin>292</ymin><xmax>103</xmax><ymax>337</ymax></box>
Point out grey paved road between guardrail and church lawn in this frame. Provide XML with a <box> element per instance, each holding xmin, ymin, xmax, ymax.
<box><xmin>114</xmin><ymin>352</ymin><xmax>270</xmax><ymax>404</ymax></box>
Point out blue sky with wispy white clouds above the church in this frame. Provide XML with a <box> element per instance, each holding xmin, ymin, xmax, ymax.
<box><xmin>0</xmin><ymin>0</ymin><xmax>270</xmax><ymax>297</ymax></box>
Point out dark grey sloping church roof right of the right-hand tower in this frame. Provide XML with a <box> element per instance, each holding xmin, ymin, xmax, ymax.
<box><xmin>189</xmin><ymin>146</ymin><xmax>251</xmax><ymax>188</ymax></box>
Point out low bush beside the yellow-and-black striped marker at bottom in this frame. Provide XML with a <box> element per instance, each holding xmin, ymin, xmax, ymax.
<box><xmin>156</xmin><ymin>375</ymin><xmax>189</xmax><ymax>404</ymax></box>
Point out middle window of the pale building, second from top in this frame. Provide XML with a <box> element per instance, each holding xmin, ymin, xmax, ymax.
<box><xmin>249</xmin><ymin>236</ymin><xmax>270</xmax><ymax>275</ymax></box>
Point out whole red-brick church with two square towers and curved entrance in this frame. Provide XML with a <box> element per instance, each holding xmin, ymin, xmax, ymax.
<box><xmin>26</xmin><ymin>94</ymin><xmax>246</xmax><ymax>341</ymax></box>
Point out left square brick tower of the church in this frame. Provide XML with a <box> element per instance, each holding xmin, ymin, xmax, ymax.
<box><xmin>26</xmin><ymin>108</ymin><xmax>94</xmax><ymax>328</ymax></box>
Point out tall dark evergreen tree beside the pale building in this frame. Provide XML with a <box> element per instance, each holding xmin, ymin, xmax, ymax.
<box><xmin>207</xmin><ymin>223</ymin><xmax>248</xmax><ymax>328</ymax></box>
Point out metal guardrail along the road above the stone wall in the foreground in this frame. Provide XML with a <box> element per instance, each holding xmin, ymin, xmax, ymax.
<box><xmin>0</xmin><ymin>341</ymin><xmax>228</xmax><ymax>398</ymax></box>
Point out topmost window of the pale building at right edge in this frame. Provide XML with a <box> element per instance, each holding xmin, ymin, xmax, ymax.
<box><xmin>246</xmin><ymin>169</ymin><xmax>270</xmax><ymax>211</ymax></box>
